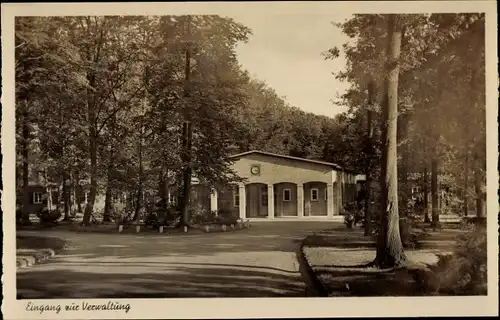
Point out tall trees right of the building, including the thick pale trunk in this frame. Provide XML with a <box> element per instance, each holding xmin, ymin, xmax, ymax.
<box><xmin>325</xmin><ymin>14</ymin><xmax>486</xmax><ymax>265</ymax></box>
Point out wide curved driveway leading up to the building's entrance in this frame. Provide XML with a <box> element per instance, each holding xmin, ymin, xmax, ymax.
<box><xmin>17</xmin><ymin>221</ymin><xmax>335</xmax><ymax>299</ymax></box>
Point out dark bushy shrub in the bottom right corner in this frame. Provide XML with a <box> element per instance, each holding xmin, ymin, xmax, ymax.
<box><xmin>417</xmin><ymin>225</ymin><xmax>487</xmax><ymax>295</ymax></box>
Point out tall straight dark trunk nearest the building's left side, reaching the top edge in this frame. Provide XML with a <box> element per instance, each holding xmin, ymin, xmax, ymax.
<box><xmin>181</xmin><ymin>16</ymin><xmax>193</xmax><ymax>227</ymax></box>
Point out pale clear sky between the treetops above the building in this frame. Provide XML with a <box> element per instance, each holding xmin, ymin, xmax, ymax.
<box><xmin>231</xmin><ymin>12</ymin><xmax>350</xmax><ymax>117</ymax></box>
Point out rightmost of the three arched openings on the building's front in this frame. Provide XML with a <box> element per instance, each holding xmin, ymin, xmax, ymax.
<box><xmin>304</xmin><ymin>181</ymin><xmax>328</xmax><ymax>216</ymax></box>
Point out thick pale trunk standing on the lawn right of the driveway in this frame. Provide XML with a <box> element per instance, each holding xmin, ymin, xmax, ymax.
<box><xmin>375</xmin><ymin>14</ymin><xmax>406</xmax><ymax>268</ymax></box>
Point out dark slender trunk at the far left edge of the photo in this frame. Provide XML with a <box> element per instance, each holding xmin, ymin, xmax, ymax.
<box><xmin>21</xmin><ymin>99</ymin><xmax>31</xmax><ymax>224</ymax></box>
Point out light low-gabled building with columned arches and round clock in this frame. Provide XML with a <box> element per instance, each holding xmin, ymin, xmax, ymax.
<box><xmin>194</xmin><ymin>151</ymin><xmax>363</xmax><ymax>219</ymax></box>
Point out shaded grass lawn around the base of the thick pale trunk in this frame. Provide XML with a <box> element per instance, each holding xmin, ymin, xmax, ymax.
<box><xmin>303</xmin><ymin>226</ymin><xmax>461</xmax><ymax>297</ymax></box>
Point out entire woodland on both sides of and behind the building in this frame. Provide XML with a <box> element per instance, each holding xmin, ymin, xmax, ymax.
<box><xmin>15</xmin><ymin>14</ymin><xmax>486</xmax><ymax>252</ymax></box>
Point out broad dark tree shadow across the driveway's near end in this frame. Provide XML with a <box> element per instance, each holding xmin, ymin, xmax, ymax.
<box><xmin>17</xmin><ymin>263</ymin><xmax>305</xmax><ymax>299</ymax></box>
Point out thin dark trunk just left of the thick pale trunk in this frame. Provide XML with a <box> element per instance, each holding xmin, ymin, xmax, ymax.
<box><xmin>364</xmin><ymin>80</ymin><xmax>374</xmax><ymax>236</ymax></box>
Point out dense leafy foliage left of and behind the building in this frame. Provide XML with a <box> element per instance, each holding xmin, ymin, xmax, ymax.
<box><xmin>16</xmin><ymin>16</ymin><xmax>351</xmax><ymax>223</ymax></box>
